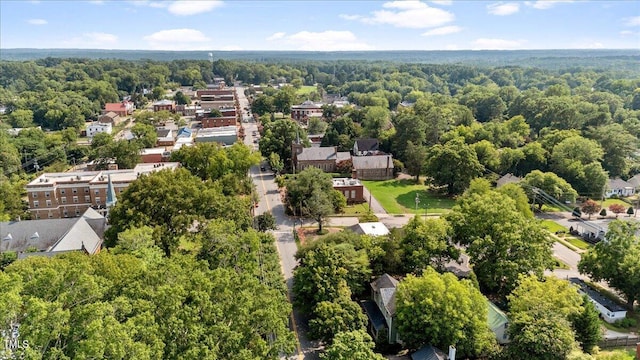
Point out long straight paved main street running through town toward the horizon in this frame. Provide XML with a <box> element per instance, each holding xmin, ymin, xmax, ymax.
<box><xmin>236</xmin><ymin>87</ymin><xmax>319</xmax><ymax>360</ymax></box>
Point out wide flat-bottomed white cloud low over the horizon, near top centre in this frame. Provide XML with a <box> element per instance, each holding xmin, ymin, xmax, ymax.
<box><xmin>272</xmin><ymin>30</ymin><xmax>374</xmax><ymax>51</ymax></box>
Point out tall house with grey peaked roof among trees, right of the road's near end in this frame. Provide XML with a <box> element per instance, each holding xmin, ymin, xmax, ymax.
<box><xmin>362</xmin><ymin>274</ymin><xmax>401</xmax><ymax>344</ymax></box>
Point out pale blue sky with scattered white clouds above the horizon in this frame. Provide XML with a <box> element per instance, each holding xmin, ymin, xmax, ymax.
<box><xmin>0</xmin><ymin>0</ymin><xmax>640</xmax><ymax>51</ymax></box>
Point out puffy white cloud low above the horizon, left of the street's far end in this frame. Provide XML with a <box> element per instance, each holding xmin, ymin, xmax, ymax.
<box><xmin>143</xmin><ymin>29</ymin><xmax>212</xmax><ymax>50</ymax></box>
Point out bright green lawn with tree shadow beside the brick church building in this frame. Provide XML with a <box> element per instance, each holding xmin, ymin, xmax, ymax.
<box><xmin>362</xmin><ymin>179</ymin><xmax>455</xmax><ymax>214</ymax></box>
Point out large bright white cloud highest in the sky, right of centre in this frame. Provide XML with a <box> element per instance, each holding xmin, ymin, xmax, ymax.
<box><xmin>341</xmin><ymin>0</ymin><xmax>455</xmax><ymax>29</ymax></box>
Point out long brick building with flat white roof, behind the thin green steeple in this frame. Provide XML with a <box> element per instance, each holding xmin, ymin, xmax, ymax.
<box><xmin>26</xmin><ymin>162</ymin><xmax>179</xmax><ymax>219</ymax></box>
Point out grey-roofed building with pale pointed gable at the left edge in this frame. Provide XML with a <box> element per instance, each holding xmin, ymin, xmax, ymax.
<box><xmin>0</xmin><ymin>208</ymin><xmax>106</xmax><ymax>259</ymax></box>
